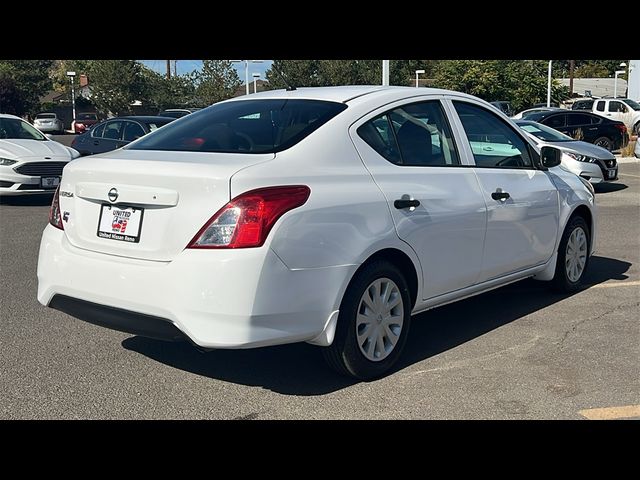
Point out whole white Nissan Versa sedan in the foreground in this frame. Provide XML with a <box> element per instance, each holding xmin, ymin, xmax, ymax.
<box><xmin>38</xmin><ymin>86</ymin><xmax>596</xmax><ymax>379</ymax></box>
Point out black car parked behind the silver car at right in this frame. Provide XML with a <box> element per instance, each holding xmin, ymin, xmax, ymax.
<box><xmin>527</xmin><ymin>110</ymin><xmax>629</xmax><ymax>151</ymax></box>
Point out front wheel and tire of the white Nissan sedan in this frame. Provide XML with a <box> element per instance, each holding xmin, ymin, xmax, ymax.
<box><xmin>551</xmin><ymin>216</ymin><xmax>591</xmax><ymax>293</ymax></box>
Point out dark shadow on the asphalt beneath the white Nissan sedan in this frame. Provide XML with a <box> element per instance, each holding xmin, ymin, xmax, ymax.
<box><xmin>122</xmin><ymin>256</ymin><xmax>631</xmax><ymax>396</ymax></box>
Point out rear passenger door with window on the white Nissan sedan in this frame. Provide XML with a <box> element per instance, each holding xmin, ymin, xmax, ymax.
<box><xmin>350</xmin><ymin>99</ymin><xmax>486</xmax><ymax>299</ymax></box>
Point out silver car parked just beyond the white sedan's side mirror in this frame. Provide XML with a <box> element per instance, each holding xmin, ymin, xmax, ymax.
<box><xmin>515</xmin><ymin>120</ymin><xmax>618</xmax><ymax>183</ymax></box>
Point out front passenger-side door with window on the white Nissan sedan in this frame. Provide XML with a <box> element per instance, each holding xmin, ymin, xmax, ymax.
<box><xmin>452</xmin><ymin>99</ymin><xmax>559</xmax><ymax>282</ymax></box>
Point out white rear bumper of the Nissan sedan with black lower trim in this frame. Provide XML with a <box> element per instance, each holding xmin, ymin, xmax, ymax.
<box><xmin>38</xmin><ymin>225</ymin><xmax>357</xmax><ymax>348</ymax></box>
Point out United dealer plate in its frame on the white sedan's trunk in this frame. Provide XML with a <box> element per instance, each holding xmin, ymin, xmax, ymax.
<box><xmin>96</xmin><ymin>204</ymin><xmax>144</xmax><ymax>243</ymax></box>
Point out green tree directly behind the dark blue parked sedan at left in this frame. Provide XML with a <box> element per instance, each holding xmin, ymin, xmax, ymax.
<box><xmin>88</xmin><ymin>60</ymin><xmax>146</xmax><ymax>115</ymax></box>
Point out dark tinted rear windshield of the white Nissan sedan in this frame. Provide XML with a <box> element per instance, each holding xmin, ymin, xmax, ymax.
<box><xmin>129</xmin><ymin>99</ymin><xmax>347</xmax><ymax>153</ymax></box>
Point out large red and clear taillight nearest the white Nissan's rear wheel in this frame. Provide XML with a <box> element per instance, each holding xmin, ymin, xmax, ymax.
<box><xmin>186</xmin><ymin>185</ymin><xmax>311</xmax><ymax>248</ymax></box>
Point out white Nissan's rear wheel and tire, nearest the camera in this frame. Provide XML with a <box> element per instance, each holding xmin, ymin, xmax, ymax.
<box><xmin>323</xmin><ymin>260</ymin><xmax>412</xmax><ymax>380</ymax></box>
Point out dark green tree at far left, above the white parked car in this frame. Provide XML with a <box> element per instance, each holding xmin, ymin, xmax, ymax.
<box><xmin>0</xmin><ymin>60</ymin><xmax>53</xmax><ymax>115</ymax></box>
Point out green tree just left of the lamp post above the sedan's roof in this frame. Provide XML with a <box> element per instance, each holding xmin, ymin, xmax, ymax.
<box><xmin>195</xmin><ymin>60</ymin><xmax>242</xmax><ymax>105</ymax></box>
